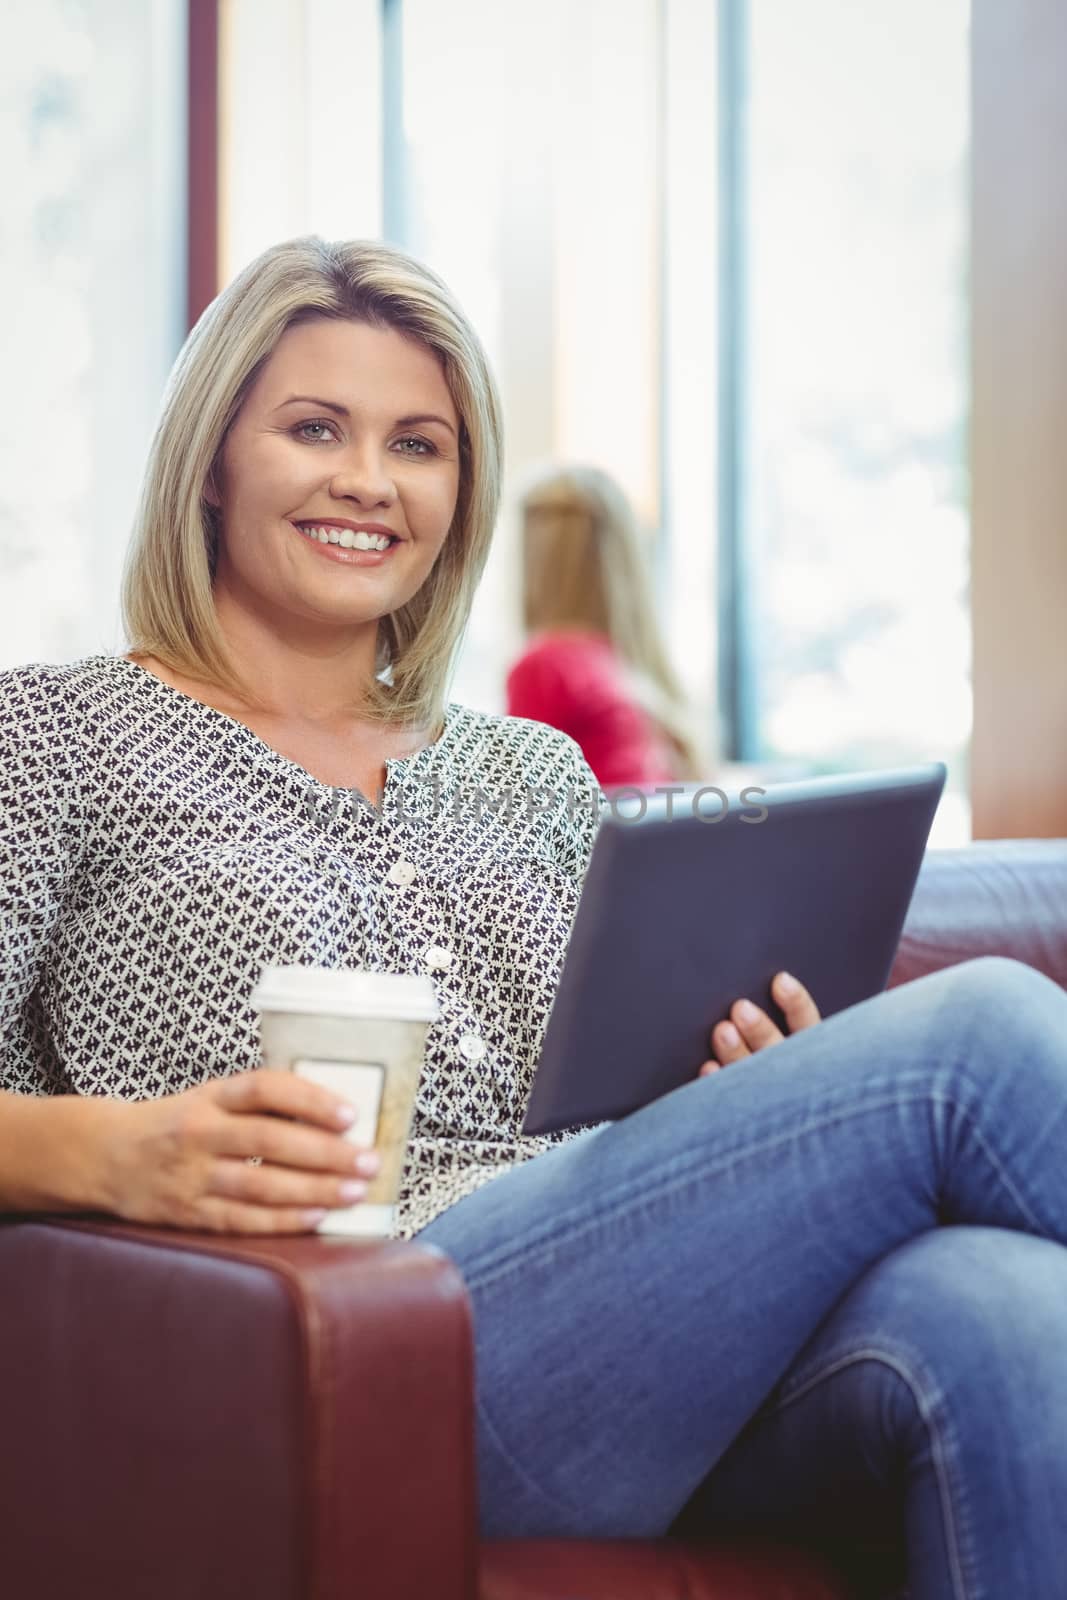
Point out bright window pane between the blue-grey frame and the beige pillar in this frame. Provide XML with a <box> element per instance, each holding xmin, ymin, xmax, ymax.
<box><xmin>723</xmin><ymin>0</ymin><xmax>971</xmax><ymax>837</ymax></box>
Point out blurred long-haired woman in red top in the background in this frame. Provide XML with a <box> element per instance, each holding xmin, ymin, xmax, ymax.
<box><xmin>507</xmin><ymin>467</ymin><xmax>701</xmax><ymax>789</ymax></box>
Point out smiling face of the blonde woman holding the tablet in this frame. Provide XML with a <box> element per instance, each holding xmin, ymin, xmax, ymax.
<box><xmin>208</xmin><ymin>317</ymin><xmax>459</xmax><ymax>659</ymax></box>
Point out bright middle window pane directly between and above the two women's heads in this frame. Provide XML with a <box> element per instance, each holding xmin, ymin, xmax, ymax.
<box><xmin>397</xmin><ymin>0</ymin><xmax>662</xmax><ymax>710</ymax></box>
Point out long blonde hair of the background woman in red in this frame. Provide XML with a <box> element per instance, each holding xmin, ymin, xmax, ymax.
<box><xmin>518</xmin><ymin>466</ymin><xmax>704</xmax><ymax>778</ymax></box>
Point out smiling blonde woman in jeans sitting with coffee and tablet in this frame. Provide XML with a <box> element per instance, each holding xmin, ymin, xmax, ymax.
<box><xmin>0</xmin><ymin>238</ymin><xmax>1067</xmax><ymax>1600</ymax></box>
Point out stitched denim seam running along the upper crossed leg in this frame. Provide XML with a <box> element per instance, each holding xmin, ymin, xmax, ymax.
<box><xmin>464</xmin><ymin>1088</ymin><xmax>998</xmax><ymax>1290</ymax></box>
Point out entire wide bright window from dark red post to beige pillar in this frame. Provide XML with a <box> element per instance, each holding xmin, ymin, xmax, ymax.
<box><xmin>221</xmin><ymin>0</ymin><xmax>969</xmax><ymax>837</ymax></box>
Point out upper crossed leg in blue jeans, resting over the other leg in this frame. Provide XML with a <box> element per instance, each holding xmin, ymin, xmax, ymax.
<box><xmin>421</xmin><ymin>960</ymin><xmax>1067</xmax><ymax>1538</ymax></box>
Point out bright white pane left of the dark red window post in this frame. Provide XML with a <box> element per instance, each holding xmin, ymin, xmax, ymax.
<box><xmin>0</xmin><ymin>0</ymin><xmax>186</xmax><ymax>666</ymax></box>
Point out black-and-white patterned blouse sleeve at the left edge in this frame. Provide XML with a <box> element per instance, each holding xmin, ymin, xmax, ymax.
<box><xmin>0</xmin><ymin>666</ymin><xmax>77</xmax><ymax>1090</ymax></box>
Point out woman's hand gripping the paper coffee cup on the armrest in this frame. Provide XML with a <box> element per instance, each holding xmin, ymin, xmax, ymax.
<box><xmin>93</xmin><ymin>1067</ymin><xmax>378</xmax><ymax>1234</ymax></box>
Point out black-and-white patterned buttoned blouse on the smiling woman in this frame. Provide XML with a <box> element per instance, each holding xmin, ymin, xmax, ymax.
<box><xmin>0</xmin><ymin>656</ymin><xmax>600</xmax><ymax>1235</ymax></box>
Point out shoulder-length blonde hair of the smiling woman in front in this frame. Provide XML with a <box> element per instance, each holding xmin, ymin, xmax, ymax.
<box><xmin>122</xmin><ymin>234</ymin><xmax>502</xmax><ymax>725</ymax></box>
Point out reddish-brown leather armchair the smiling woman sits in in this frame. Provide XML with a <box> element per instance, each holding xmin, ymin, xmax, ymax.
<box><xmin>0</xmin><ymin>842</ymin><xmax>1067</xmax><ymax>1600</ymax></box>
